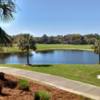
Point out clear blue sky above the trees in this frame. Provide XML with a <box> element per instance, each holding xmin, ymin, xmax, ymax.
<box><xmin>0</xmin><ymin>0</ymin><xmax>100</xmax><ymax>36</ymax></box>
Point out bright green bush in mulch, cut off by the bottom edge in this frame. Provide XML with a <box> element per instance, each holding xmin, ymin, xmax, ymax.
<box><xmin>34</xmin><ymin>91</ymin><xmax>51</xmax><ymax>100</ymax></box>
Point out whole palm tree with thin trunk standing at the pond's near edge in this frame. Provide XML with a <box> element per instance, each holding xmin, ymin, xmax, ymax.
<box><xmin>18</xmin><ymin>34</ymin><xmax>36</xmax><ymax>65</ymax></box>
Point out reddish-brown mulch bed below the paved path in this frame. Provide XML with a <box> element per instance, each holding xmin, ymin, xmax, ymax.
<box><xmin>0</xmin><ymin>74</ymin><xmax>89</xmax><ymax>100</ymax></box>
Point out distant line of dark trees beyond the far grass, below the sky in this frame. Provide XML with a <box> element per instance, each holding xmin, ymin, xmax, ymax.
<box><xmin>13</xmin><ymin>34</ymin><xmax>100</xmax><ymax>44</ymax></box>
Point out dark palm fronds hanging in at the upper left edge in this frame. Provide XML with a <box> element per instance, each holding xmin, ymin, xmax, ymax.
<box><xmin>0</xmin><ymin>0</ymin><xmax>15</xmax><ymax>45</ymax></box>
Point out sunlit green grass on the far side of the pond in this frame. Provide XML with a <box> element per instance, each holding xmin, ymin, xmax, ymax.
<box><xmin>0</xmin><ymin>44</ymin><xmax>92</xmax><ymax>53</ymax></box>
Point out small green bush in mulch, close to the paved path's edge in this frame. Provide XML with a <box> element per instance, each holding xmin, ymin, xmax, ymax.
<box><xmin>19</xmin><ymin>79</ymin><xmax>29</xmax><ymax>91</ymax></box>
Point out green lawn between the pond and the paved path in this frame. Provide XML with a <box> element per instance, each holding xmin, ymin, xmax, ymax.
<box><xmin>0</xmin><ymin>64</ymin><xmax>100</xmax><ymax>86</ymax></box>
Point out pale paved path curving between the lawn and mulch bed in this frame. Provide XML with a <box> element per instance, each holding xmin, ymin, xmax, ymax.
<box><xmin>0</xmin><ymin>67</ymin><xmax>100</xmax><ymax>100</ymax></box>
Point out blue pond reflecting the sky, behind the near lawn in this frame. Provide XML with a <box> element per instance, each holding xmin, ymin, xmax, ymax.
<box><xmin>0</xmin><ymin>50</ymin><xmax>99</xmax><ymax>64</ymax></box>
